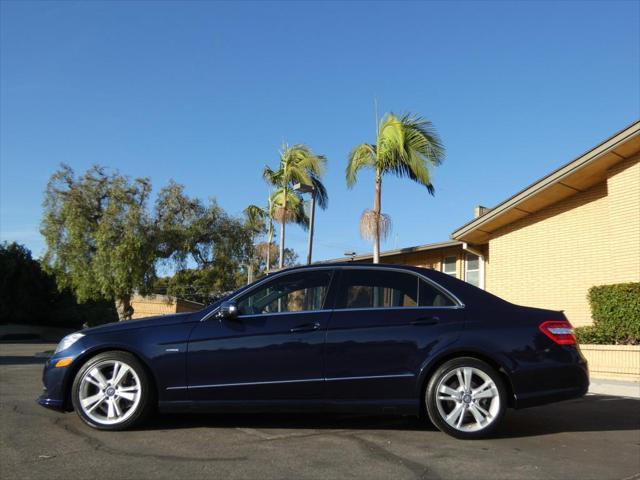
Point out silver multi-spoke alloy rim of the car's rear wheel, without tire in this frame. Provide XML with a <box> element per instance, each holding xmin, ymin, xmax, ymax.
<box><xmin>436</xmin><ymin>367</ymin><xmax>500</xmax><ymax>432</ymax></box>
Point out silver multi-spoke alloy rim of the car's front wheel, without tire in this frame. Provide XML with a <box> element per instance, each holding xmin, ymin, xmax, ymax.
<box><xmin>78</xmin><ymin>360</ymin><xmax>142</xmax><ymax>425</ymax></box>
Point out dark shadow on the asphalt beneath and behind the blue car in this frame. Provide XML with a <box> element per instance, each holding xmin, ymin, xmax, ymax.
<box><xmin>137</xmin><ymin>395</ymin><xmax>640</xmax><ymax>438</ymax></box>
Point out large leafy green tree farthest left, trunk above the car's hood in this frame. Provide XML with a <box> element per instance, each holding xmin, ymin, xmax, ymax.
<box><xmin>41</xmin><ymin>165</ymin><xmax>157</xmax><ymax>319</ymax></box>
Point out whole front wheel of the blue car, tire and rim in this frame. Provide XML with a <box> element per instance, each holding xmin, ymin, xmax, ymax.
<box><xmin>71</xmin><ymin>352</ymin><xmax>153</xmax><ymax>430</ymax></box>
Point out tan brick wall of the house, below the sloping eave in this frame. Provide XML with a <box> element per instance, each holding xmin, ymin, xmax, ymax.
<box><xmin>485</xmin><ymin>157</ymin><xmax>640</xmax><ymax>326</ymax></box>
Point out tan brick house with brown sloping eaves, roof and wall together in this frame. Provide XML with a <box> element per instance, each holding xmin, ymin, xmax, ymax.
<box><xmin>328</xmin><ymin>121</ymin><xmax>640</xmax><ymax>326</ymax></box>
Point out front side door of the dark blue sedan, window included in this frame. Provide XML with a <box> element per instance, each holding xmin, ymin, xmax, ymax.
<box><xmin>187</xmin><ymin>269</ymin><xmax>333</xmax><ymax>404</ymax></box>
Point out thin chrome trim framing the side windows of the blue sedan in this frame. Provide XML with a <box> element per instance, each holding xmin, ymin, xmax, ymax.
<box><xmin>200</xmin><ymin>264</ymin><xmax>465</xmax><ymax>322</ymax></box>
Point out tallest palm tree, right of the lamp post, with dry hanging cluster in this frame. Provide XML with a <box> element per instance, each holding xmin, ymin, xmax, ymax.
<box><xmin>346</xmin><ymin>113</ymin><xmax>444</xmax><ymax>263</ymax></box>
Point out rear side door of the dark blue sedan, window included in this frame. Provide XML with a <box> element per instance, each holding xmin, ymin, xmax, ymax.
<box><xmin>325</xmin><ymin>267</ymin><xmax>464</xmax><ymax>405</ymax></box>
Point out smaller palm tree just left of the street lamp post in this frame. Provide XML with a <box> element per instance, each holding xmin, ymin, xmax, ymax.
<box><xmin>263</xmin><ymin>144</ymin><xmax>326</xmax><ymax>268</ymax></box>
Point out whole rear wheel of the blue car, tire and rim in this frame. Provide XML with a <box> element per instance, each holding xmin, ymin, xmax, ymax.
<box><xmin>425</xmin><ymin>357</ymin><xmax>507</xmax><ymax>439</ymax></box>
